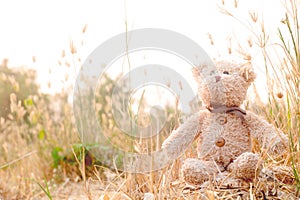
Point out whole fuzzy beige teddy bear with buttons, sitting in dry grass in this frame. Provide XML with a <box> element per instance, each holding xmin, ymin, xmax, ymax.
<box><xmin>162</xmin><ymin>62</ymin><xmax>288</xmax><ymax>185</ymax></box>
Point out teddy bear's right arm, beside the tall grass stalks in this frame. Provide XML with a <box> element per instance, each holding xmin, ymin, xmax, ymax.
<box><xmin>245</xmin><ymin>111</ymin><xmax>288</xmax><ymax>155</ymax></box>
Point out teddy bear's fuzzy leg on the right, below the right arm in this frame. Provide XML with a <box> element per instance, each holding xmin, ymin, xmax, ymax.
<box><xmin>228</xmin><ymin>152</ymin><xmax>262</xmax><ymax>181</ymax></box>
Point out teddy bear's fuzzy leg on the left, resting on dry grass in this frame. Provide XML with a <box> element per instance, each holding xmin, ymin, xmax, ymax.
<box><xmin>181</xmin><ymin>158</ymin><xmax>218</xmax><ymax>185</ymax></box>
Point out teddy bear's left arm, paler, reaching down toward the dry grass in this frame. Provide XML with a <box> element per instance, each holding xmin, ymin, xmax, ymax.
<box><xmin>162</xmin><ymin>110</ymin><xmax>209</xmax><ymax>160</ymax></box>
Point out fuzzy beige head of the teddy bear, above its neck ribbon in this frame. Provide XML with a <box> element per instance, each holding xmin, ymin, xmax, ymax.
<box><xmin>193</xmin><ymin>62</ymin><xmax>256</xmax><ymax>108</ymax></box>
